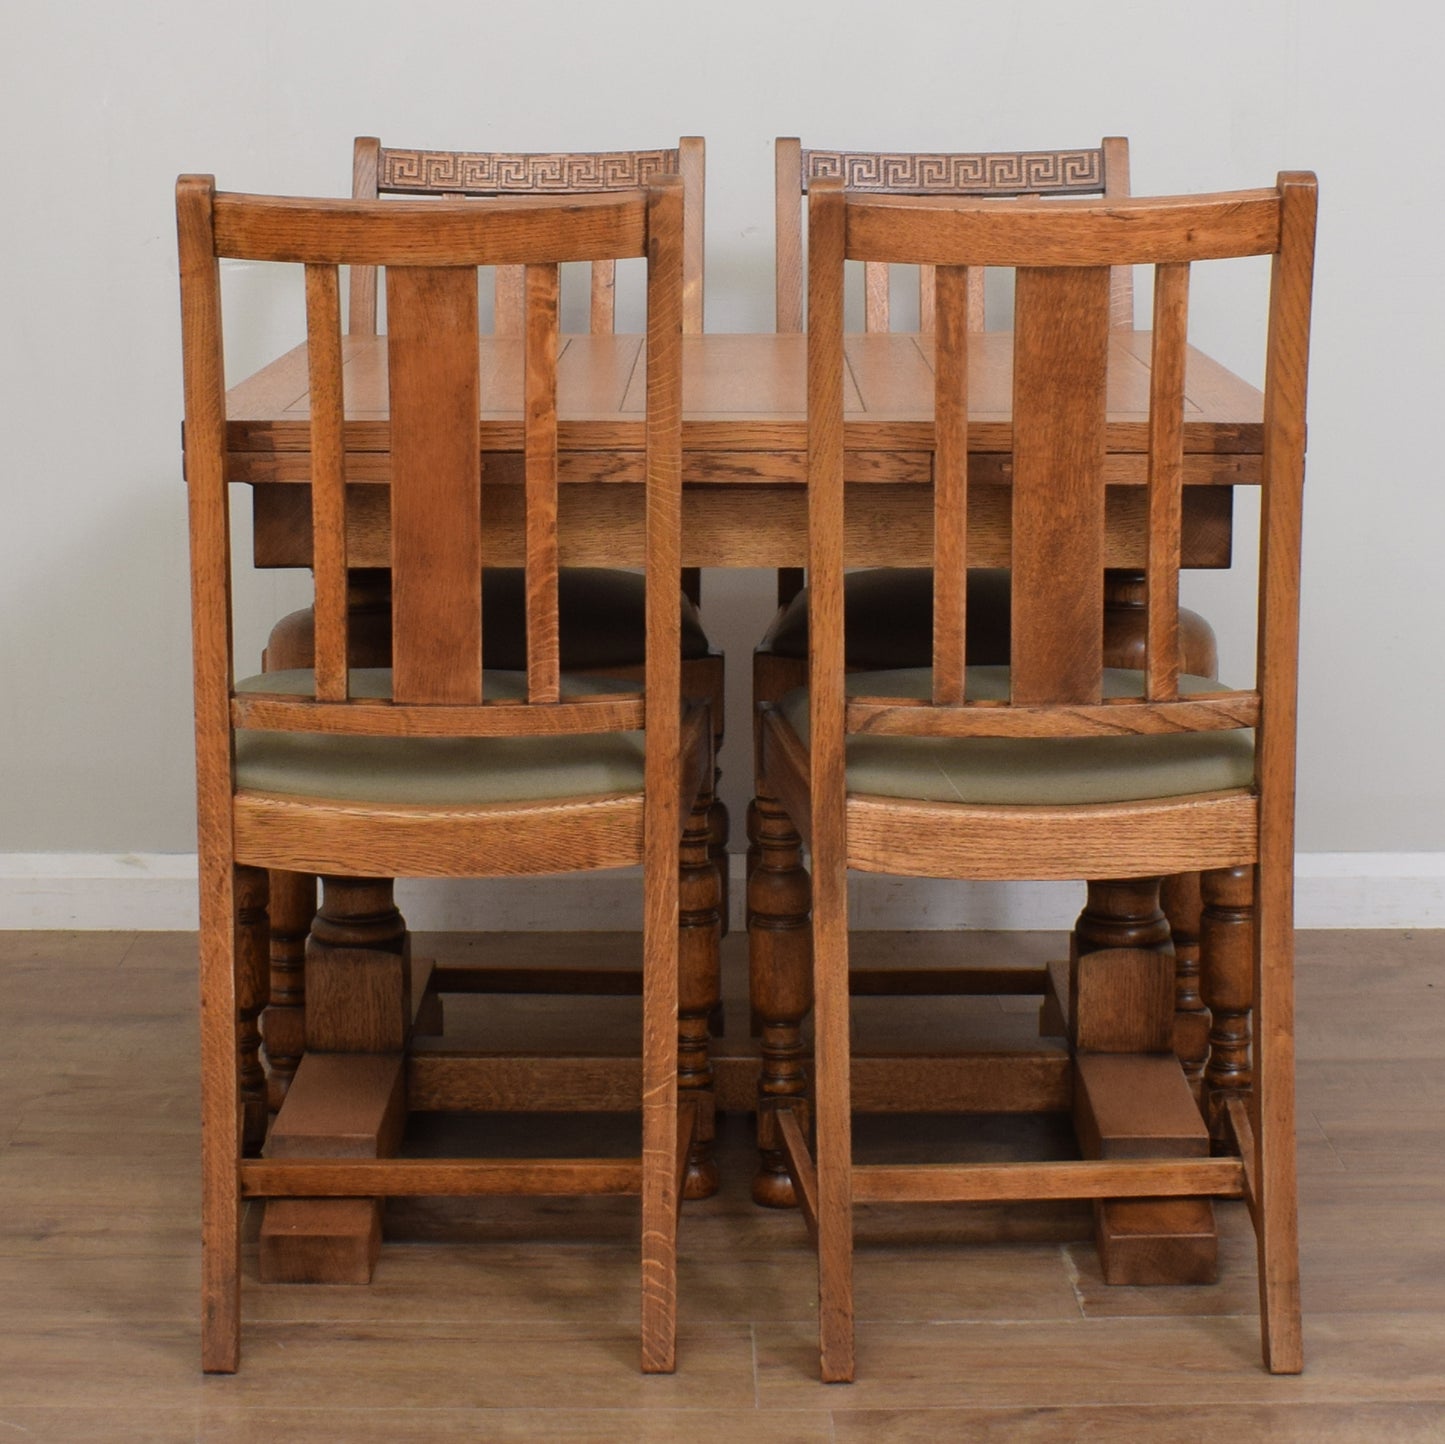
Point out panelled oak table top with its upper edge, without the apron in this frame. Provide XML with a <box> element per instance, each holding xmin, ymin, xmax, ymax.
<box><xmin>228</xmin><ymin>331</ymin><xmax>1261</xmax><ymax>459</ymax></box>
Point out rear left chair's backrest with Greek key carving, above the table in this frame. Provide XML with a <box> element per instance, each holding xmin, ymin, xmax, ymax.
<box><xmin>347</xmin><ymin>136</ymin><xmax>705</xmax><ymax>335</ymax></box>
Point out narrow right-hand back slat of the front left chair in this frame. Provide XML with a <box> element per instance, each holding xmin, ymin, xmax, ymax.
<box><xmin>523</xmin><ymin>266</ymin><xmax>561</xmax><ymax>702</ymax></box>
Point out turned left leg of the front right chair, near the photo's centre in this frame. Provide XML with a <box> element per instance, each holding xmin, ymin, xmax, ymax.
<box><xmin>747</xmin><ymin>795</ymin><xmax>812</xmax><ymax>1208</ymax></box>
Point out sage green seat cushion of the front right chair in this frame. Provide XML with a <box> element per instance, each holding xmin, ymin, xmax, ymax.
<box><xmin>780</xmin><ymin>666</ymin><xmax>1254</xmax><ymax>807</ymax></box>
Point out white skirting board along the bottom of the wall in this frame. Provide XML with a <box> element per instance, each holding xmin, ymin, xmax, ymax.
<box><xmin>0</xmin><ymin>853</ymin><xmax>1445</xmax><ymax>932</ymax></box>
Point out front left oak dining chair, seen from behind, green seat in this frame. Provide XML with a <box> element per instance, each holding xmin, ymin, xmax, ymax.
<box><xmin>176</xmin><ymin>176</ymin><xmax>717</xmax><ymax>1372</ymax></box>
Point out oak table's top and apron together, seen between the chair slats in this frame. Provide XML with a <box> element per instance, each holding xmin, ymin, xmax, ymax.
<box><xmin>228</xmin><ymin>331</ymin><xmax>1261</xmax><ymax>568</ymax></box>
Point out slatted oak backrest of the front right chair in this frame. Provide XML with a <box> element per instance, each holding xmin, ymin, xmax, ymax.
<box><xmin>808</xmin><ymin>175</ymin><xmax>1315</xmax><ymax>766</ymax></box>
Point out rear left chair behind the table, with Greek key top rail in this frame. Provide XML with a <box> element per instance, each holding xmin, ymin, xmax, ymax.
<box><xmin>251</xmin><ymin>136</ymin><xmax>728</xmax><ymax>1139</ymax></box>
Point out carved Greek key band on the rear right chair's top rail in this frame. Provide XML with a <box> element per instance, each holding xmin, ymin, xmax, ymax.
<box><xmin>802</xmin><ymin>149</ymin><xmax>1104</xmax><ymax>195</ymax></box>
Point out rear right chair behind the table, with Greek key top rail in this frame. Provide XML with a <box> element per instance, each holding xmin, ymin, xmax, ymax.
<box><xmin>749</xmin><ymin>136</ymin><xmax>1218</xmax><ymax>1219</ymax></box>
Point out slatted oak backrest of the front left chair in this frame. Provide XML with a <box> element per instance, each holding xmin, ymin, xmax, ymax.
<box><xmin>176</xmin><ymin>176</ymin><xmax>682</xmax><ymax>781</ymax></box>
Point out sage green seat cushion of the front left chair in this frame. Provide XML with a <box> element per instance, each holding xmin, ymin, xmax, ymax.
<box><xmin>236</xmin><ymin>668</ymin><xmax>643</xmax><ymax>807</ymax></box>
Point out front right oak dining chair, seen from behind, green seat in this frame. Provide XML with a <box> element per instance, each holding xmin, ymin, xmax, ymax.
<box><xmin>760</xmin><ymin>173</ymin><xmax>1316</xmax><ymax>1380</ymax></box>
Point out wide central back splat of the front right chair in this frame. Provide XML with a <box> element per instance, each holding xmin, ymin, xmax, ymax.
<box><xmin>1012</xmin><ymin>266</ymin><xmax>1110</xmax><ymax>704</ymax></box>
